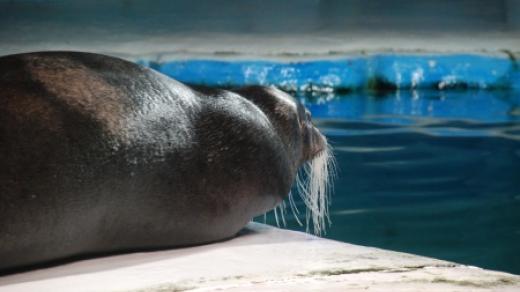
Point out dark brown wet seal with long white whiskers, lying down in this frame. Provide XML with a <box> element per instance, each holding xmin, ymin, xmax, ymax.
<box><xmin>0</xmin><ymin>52</ymin><xmax>331</xmax><ymax>271</ymax></box>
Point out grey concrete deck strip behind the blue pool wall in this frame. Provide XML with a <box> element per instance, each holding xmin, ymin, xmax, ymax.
<box><xmin>0</xmin><ymin>31</ymin><xmax>520</xmax><ymax>62</ymax></box>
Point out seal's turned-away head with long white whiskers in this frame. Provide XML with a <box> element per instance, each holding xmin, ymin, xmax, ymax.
<box><xmin>236</xmin><ymin>86</ymin><xmax>334</xmax><ymax>234</ymax></box>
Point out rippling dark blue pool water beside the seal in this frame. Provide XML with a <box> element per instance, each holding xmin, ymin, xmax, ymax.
<box><xmin>256</xmin><ymin>90</ymin><xmax>520</xmax><ymax>274</ymax></box>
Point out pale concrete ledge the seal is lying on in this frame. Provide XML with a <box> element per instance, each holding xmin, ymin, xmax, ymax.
<box><xmin>0</xmin><ymin>223</ymin><xmax>520</xmax><ymax>292</ymax></box>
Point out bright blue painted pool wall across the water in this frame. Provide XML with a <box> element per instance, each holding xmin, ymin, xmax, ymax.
<box><xmin>139</xmin><ymin>54</ymin><xmax>520</xmax><ymax>91</ymax></box>
